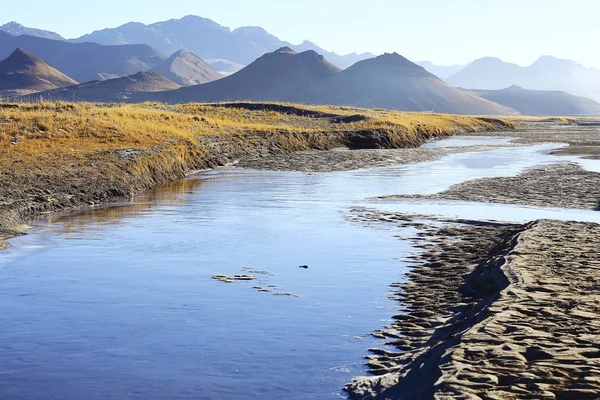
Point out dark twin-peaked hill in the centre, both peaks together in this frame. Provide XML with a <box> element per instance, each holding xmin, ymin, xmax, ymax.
<box><xmin>141</xmin><ymin>47</ymin><xmax>516</xmax><ymax>114</ymax></box>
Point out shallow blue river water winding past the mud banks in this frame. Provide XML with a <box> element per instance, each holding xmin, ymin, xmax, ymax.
<box><xmin>0</xmin><ymin>138</ymin><xmax>597</xmax><ymax>399</ymax></box>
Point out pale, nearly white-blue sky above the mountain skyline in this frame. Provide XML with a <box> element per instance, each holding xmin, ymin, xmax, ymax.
<box><xmin>0</xmin><ymin>0</ymin><xmax>600</xmax><ymax>68</ymax></box>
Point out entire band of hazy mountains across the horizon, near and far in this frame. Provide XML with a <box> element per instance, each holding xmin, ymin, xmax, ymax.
<box><xmin>0</xmin><ymin>16</ymin><xmax>600</xmax><ymax>115</ymax></box>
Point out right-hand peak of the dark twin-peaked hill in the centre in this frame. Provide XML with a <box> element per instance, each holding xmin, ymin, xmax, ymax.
<box><xmin>289</xmin><ymin>53</ymin><xmax>515</xmax><ymax>115</ymax></box>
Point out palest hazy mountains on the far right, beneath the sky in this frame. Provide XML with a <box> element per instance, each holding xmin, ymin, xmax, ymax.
<box><xmin>446</xmin><ymin>56</ymin><xmax>600</xmax><ymax>100</ymax></box>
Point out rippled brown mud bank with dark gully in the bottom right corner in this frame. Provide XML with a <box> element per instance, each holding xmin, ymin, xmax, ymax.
<box><xmin>346</xmin><ymin>210</ymin><xmax>600</xmax><ymax>400</ymax></box>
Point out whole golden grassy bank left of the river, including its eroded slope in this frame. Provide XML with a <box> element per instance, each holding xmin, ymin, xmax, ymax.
<box><xmin>0</xmin><ymin>103</ymin><xmax>512</xmax><ymax>247</ymax></box>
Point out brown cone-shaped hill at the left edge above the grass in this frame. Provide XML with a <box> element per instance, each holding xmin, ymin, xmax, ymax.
<box><xmin>0</xmin><ymin>49</ymin><xmax>77</xmax><ymax>98</ymax></box>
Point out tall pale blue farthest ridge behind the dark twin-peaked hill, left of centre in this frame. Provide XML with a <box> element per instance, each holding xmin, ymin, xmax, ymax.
<box><xmin>74</xmin><ymin>15</ymin><xmax>372</xmax><ymax>68</ymax></box>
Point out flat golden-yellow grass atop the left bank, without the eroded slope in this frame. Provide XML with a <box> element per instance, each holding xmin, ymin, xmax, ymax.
<box><xmin>0</xmin><ymin>103</ymin><xmax>512</xmax><ymax>162</ymax></box>
